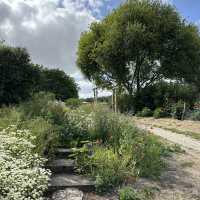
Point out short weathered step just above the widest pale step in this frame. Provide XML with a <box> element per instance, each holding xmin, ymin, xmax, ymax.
<box><xmin>47</xmin><ymin>159</ymin><xmax>75</xmax><ymax>174</ymax></box>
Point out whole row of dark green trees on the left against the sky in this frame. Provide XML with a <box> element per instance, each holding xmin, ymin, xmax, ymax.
<box><xmin>0</xmin><ymin>44</ymin><xmax>78</xmax><ymax>105</ymax></box>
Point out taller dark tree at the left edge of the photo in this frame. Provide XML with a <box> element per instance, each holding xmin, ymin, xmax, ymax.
<box><xmin>0</xmin><ymin>44</ymin><xmax>40</xmax><ymax>105</ymax></box>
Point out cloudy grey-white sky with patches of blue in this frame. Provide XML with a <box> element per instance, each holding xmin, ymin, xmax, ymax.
<box><xmin>0</xmin><ymin>0</ymin><xmax>200</xmax><ymax>97</ymax></box>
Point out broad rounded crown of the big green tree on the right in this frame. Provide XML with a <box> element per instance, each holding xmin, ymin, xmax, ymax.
<box><xmin>77</xmin><ymin>0</ymin><xmax>200</xmax><ymax>95</ymax></box>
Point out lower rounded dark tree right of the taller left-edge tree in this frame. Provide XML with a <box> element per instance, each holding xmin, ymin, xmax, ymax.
<box><xmin>40</xmin><ymin>69</ymin><xmax>78</xmax><ymax>101</ymax></box>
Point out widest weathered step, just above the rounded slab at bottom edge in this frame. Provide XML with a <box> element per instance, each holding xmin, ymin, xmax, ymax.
<box><xmin>49</xmin><ymin>174</ymin><xmax>95</xmax><ymax>193</ymax></box>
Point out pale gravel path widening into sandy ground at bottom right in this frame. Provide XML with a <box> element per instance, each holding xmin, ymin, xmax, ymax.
<box><xmin>137</xmin><ymin>124</ymin><xmax>200</xmax><ymax>200</ymax></box>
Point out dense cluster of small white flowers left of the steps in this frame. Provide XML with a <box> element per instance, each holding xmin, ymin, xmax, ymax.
<box><xmin>0</xmin><ymin>126</ymin><xmax>50</xmax><ymax>200</ymax></box>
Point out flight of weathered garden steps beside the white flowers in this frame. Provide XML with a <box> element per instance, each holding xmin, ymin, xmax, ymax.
<box><xmin>47</xmin><ymin>148</ymin><xmax>94</xmax><ymax>200</ymax></box>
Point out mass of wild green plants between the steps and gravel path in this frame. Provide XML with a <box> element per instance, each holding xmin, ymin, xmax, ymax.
<box><xmin>76</xmin><ymin>107</ymin><xmax>172</xmax><ymax>191</ymax></box>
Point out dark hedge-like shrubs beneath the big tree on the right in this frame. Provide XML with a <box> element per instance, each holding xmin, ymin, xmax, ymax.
<box><xmin>118</xmin><ymin>81</ymin><xmax>199</xmax><ymax>114</ymax></box>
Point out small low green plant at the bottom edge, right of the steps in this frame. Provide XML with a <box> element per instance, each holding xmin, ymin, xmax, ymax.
<box><xmin>119</xmin><ymin>187</ymin><xmax>144</xmax><ymax>200</ymax></box>
